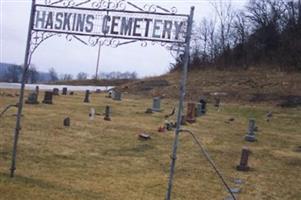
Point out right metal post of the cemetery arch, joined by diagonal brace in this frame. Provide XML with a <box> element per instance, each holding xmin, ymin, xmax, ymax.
<box><xmin>165</xmin><ymin>7</ymin><xmax>194</xmax><ymax>200</ymax></box>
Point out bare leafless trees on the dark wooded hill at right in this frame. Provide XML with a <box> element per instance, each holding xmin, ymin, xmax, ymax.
<box><xmin>171</xmin><ymin>0</ymin><xmax>301</xmax><ymax>71</ymax></box>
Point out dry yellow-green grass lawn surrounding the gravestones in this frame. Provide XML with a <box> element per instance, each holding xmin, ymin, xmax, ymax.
<box><xmin>0</xmin><ymin>90</ymin><xmax>301</xmax><ymax>200</ymax></box>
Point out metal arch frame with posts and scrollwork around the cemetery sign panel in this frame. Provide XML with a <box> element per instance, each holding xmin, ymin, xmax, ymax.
<box><xmin>10</xmin><ymin>0</ymin><xmax>194</xmax><ymax>200</ymax></box>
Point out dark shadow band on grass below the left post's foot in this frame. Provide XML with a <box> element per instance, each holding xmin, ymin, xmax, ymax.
<box><xmin>0</xmin><ymin>172</ymin><xmax>104</xmax><ymax>199</ymax></box>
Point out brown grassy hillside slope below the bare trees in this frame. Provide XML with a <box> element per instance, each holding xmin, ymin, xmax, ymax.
<box><xmin>119</xmin><ymin>69</ymin><xmax>301</xmax><ymax>102</ymax></box>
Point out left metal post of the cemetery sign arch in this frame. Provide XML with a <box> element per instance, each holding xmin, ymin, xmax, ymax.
<box><xmin>10</xmin><ymin>0</ymin><xmax>36</xmax><ymax>177</ymax></box>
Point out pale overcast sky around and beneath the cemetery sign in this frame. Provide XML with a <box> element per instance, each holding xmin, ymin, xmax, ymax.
<box><xmin>0</xmin><ymin>0</ymin><xmax>245</xmax><ymax>77</ymax></box>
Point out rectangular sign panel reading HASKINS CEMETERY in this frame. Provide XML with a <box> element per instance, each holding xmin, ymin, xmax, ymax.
<box><xmin>34</xmin><ymin>5</ymin><xmax>188</xmax><ymax>43</ymax></box>
